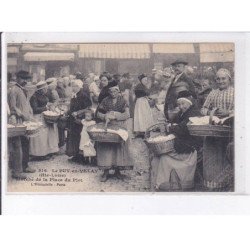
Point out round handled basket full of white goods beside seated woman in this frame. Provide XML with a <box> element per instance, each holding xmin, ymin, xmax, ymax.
<box><xmin>145</xmin><ymin>123</ymin><xmax>175</xmax><ymax>155</ymax></box>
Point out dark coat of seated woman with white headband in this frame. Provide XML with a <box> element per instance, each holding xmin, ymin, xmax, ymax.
<box><xmin>170</xmin><ymin>105</ymin><xmax>202</xmax><ymax>154</ymax></box>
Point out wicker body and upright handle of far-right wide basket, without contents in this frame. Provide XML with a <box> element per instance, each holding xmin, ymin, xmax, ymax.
<box><xmin>187</xmin><ymin>109</ymin><xmax>233</xmax><ymax>137</ymax></box>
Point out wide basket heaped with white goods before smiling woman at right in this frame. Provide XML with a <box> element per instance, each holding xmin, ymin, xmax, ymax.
<box><xmin>187</xmin><ymin>109</ymin><xmax>233</xmax><ymax>137</ymax></box>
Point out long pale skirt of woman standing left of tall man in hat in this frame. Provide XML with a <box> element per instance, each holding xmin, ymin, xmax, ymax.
<box><xmin>134</xmin><ymin>97</ymin><xmax>154</xmax><ymax>132</ymax></box>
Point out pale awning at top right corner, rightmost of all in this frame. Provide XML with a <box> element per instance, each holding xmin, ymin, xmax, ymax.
<box><xmin>200</xmin><ymin>43</ymin><xmax>234</xmax><ymax>63</ymax></box>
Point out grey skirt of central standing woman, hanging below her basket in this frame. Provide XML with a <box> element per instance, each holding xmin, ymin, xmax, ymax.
<box><xmin>96</xmin><ymin>121</ymin><xmax>133</xmax><ymax>170</ymax></box>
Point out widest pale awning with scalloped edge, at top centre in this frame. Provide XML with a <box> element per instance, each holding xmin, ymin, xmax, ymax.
<box><xmin>79</xmin><ymin>43</ymin><xmax>150</xmax><ymax>59</ymax></box>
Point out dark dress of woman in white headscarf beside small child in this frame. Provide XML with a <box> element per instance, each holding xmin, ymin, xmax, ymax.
<box><xmin>66</xmin><ymin>89</ymin><xmax>92</xmax><ymax>156</ymax></box>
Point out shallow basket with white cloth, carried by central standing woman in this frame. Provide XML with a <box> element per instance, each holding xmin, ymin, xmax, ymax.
<box><xmin>87</xmin><ymin>124</ymin><xmax>128</xmax><ymax>143</ymax></box>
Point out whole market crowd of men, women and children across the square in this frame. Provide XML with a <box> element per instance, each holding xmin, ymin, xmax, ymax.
<box><xmin>8</xmin><ymin>60</ymin><xmax>234</xmax><ymax>190</ymax></box>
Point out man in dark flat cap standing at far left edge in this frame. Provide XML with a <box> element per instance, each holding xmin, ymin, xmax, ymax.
<box><xmin>8</xmin><ymin>70</ymin><xmax>35</xmax><ymax>179</ymax></box>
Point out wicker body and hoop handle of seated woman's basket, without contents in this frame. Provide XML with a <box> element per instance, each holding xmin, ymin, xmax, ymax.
<box><xmin>145</xmin><ymin>123</ymin><xmax>174</xmax><ymax>155</ymax></box>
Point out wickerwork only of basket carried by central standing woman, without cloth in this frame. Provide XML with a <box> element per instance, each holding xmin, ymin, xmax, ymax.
<box><xmin>87</xmin><ymin>124</ymin><xmax>125</xmax><ymax>143</ymax></box>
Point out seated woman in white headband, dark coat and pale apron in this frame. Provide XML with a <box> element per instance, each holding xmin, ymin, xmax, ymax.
<box><xmin>151</xmin><ymin>91</ymin><xmax>202</xmax><ymax>191</ymax></box>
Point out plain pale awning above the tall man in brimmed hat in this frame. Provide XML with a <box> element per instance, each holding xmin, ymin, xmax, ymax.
<box><xmin>153</xmin><ymin>43</ymin><xmax>195</xmax><ymax>54</ymax></box>
